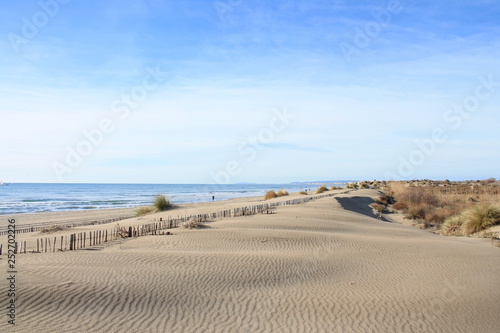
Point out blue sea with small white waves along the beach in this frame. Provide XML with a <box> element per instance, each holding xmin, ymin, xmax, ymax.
<box><xmin>0</xmin><ymin>183</ymin><xmax>344</xmax><ymax>215</ymax></box>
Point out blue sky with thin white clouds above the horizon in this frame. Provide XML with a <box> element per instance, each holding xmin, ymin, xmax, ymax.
<box><xmin>0</xmin><ymin>0</ymin><xmax>500</xmax><ymax>184</ymax></box>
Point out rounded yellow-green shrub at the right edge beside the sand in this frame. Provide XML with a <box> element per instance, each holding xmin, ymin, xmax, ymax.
<box><xmin>460</xmin><ymin>204</ymin><xmax>500</xmax><ymax>236</ymax></box>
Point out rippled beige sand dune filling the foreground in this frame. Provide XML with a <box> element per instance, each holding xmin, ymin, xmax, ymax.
<box><xmin>0</xmin><ymin>190</ymin><xmax>500</xmax><ymax>333</ymax></box>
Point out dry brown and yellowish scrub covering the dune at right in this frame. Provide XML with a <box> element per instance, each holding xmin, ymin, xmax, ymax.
<box><xmin>379</xmin><ymin>178</ymin><xmax>500</xmax><ymax>236</ymax></box>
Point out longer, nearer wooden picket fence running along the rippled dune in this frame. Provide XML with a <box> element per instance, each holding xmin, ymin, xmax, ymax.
<box><xmin>0</xmin><ymin>191</ymin><xmax>349</xmax><ymax>255</ymax></box>
